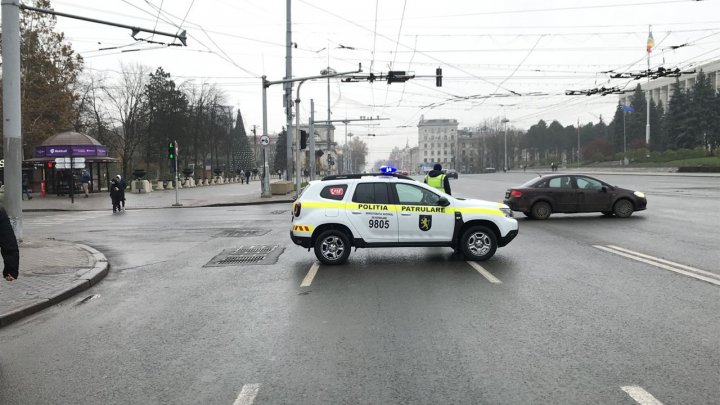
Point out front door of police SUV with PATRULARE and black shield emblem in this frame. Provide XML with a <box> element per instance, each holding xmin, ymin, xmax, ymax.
<box><xmin>393</xmin><ymin>183</ymin><xmax>455</xmax><ymax>242</ymax></box>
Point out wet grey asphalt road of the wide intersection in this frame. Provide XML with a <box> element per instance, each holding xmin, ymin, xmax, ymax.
<box><xmin>0</xmin><ymin>173</ymin><xmax>720</xmax><ymax>404</ymax></box>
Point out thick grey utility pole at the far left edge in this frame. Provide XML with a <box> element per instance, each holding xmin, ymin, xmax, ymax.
<box><xmin>2</xmin><ymin>0</ymin><xmax>23</xmax><ymax>241</ymax></box>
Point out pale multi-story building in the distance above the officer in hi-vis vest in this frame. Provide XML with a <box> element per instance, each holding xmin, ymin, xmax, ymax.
<box><xmin>418</xmin><ymin>116</ymin><xmax>458</xmax><ymax>171</ymax></box>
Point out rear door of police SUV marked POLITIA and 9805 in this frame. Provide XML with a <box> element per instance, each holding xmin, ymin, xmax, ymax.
<box><xmin>347</xmin><ymin>182</ymin><xmax>398</xmax><ymax>243</ymax></box>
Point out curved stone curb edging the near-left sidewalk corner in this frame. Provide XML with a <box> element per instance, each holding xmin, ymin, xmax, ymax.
<box><xmin>0</xmin><ymin>243</ymin><xmax>110</xmax><ymax>328</ymax></box>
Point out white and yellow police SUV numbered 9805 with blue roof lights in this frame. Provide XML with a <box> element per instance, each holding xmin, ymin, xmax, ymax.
<box><xmin>290</xmin><ymin>170</ymin><xmax>518</xmax><ymax>264</ymax></box>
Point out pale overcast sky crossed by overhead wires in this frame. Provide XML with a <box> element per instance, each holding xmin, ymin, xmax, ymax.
<box><xmin>52</xmin><ymin>0</ymin><xmax>720</xmax><ymax>162</ymax></box>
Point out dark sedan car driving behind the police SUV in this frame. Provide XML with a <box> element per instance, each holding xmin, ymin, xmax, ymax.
<box><xmin>503</xmin><ymin>174</ymin><xmax>647</xmax><ymax>219</ymax></box>
